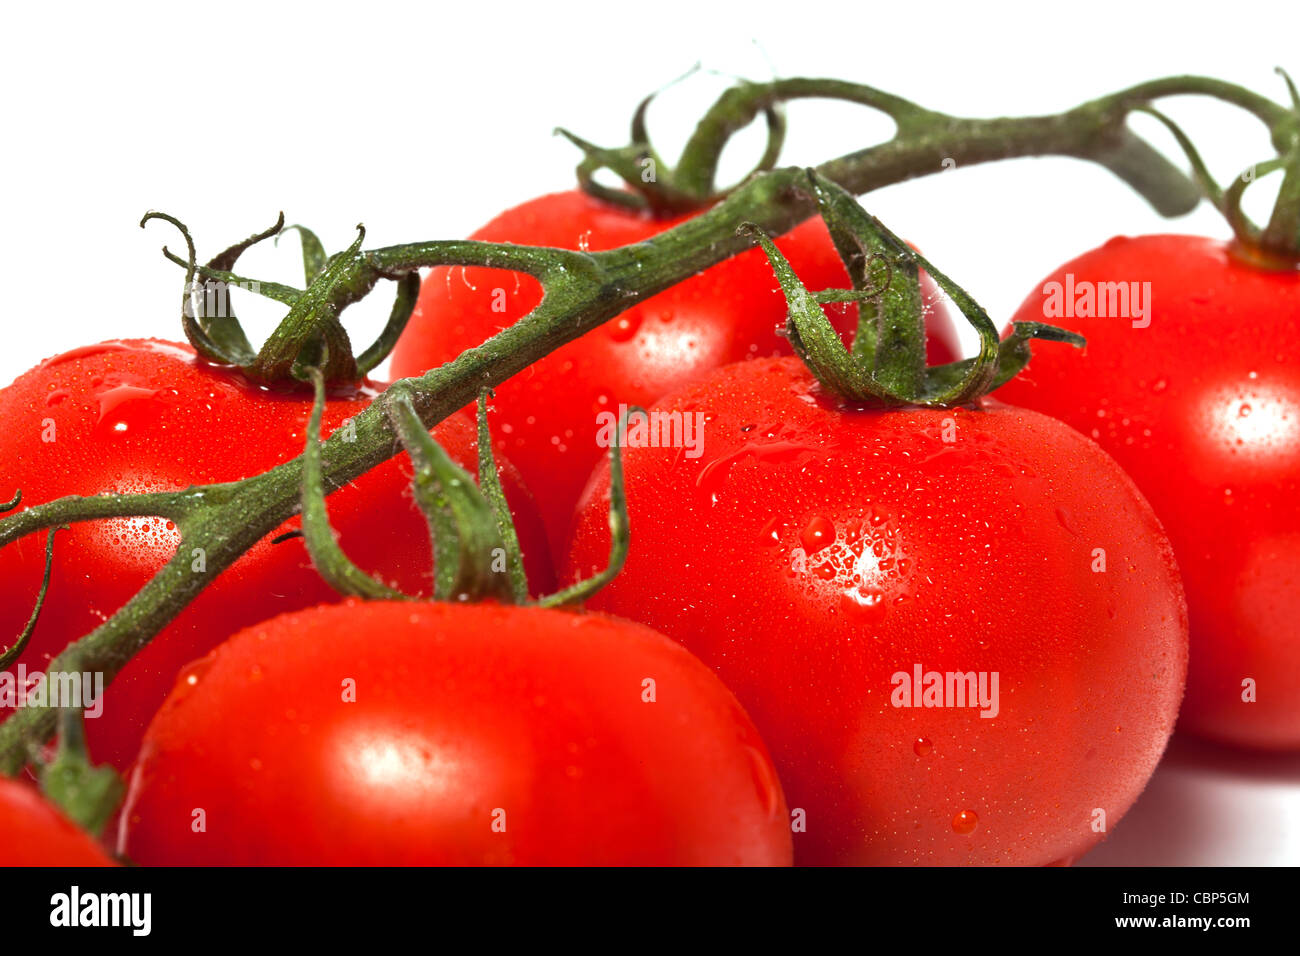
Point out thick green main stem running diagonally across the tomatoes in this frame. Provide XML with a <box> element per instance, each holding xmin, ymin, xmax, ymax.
<box><xmin>0</xmin><ymin>77</ymin><xmax>1294</xmax><ymax>774</ymax></box>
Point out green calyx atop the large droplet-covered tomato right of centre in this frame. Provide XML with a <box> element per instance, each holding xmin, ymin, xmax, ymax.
<box><xmin>741</xmin><ymin>169</ymin><xmax>1084</xmax><ymax>408</ymax></box>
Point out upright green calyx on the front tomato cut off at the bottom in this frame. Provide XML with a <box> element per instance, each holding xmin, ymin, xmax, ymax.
<box><xmin>302</xmin><ymin>368</ymin><xmax>628</xmax><ymax>607</ymax></box>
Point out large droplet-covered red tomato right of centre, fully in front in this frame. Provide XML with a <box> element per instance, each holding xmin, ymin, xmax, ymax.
<box><xmin>568</xmin><ymin>359</ymin><xmax>1187</xmax><ymax>865</ymax></box>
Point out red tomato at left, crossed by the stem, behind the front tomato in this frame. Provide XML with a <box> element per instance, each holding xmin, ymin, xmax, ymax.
<box><xmin>0</xmin><ymin>339</ymin><xmax>553</xmax><ymax>769</ymax></box>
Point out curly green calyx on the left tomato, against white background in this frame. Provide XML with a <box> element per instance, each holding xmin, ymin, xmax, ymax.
<box><xmin>140</xmin><ymin>212</ymin><xmax>420</xmax><ymax>385</ymax></box>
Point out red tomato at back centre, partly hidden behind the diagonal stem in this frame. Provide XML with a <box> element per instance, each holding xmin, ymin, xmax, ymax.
<box><xmin>393</xmin><ymin>190</ymin><xmax>958</xmax><ymax>555</ymax></box>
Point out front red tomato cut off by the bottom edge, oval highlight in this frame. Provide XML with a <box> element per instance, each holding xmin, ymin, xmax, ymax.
<box><xmin>120</xmin><ymin>602</ymin><xmax>792</xmax><ymax>865</ymax></box>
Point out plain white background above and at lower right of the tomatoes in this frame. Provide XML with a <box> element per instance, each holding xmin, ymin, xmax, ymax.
<box><xmin>0</xmin><ymin>0</ymin><xmax>1300</xmax><ymax>864</ymax></box>
